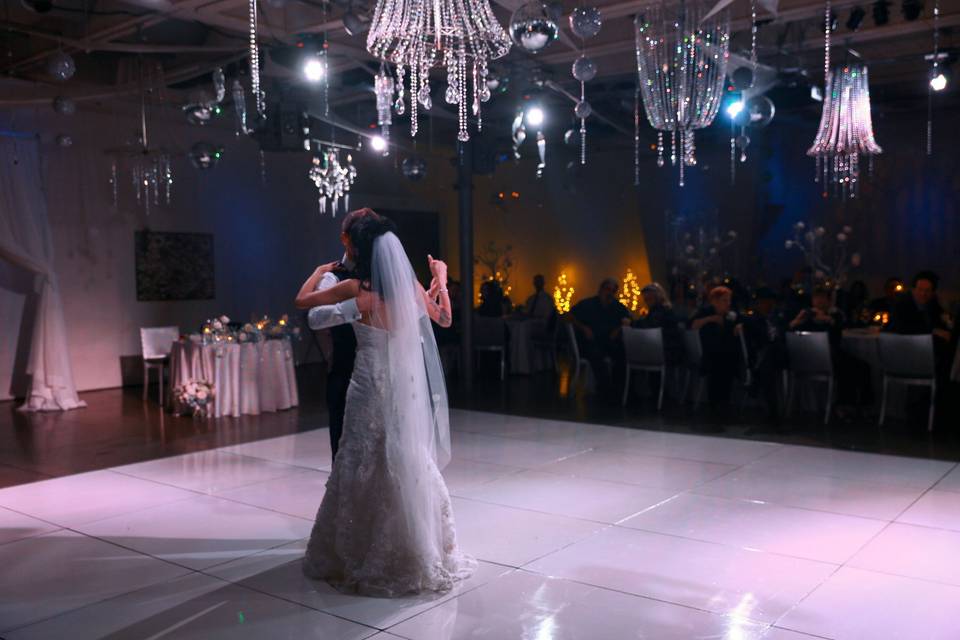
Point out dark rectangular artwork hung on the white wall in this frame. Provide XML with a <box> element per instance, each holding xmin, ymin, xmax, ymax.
<box><xmin>134</xmin><ymin>231</ymin><xmax>216</xmax><ymax>302</ymax></box>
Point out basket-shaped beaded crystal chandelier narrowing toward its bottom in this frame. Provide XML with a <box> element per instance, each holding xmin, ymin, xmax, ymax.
<box><xmin>634</xmin><ymin>0</ymin><xmax>730</xmax><ymax>186</ymax></box>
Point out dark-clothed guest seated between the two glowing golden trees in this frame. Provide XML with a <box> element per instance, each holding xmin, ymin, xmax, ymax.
<box><xmin>568</xmin><ymin>278</ymin><xmax>630</xmax><ymax>402</ymax></box>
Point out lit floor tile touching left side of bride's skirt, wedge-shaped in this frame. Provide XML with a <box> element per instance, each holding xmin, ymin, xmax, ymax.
<box><xmin>215</xmin><ymin>469</ymin><xmax>330</xmax><ymax>520</ymax></box>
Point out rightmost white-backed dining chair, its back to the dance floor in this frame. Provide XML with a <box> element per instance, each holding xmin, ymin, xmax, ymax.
<box><xmin>879</xmin><ymin>333</ymin><xmax>937</xmax><ymax>432</ymax></box>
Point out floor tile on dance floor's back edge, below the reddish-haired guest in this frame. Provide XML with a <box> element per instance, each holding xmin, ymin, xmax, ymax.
<box><xmin>604</xmin><ymin>431</ymin><xmax>783</xmax><ymax>465</ymax></box>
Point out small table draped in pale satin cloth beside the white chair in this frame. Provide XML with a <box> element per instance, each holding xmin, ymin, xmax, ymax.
<box><xmin>170</xmin><ymin>339</ymin><xmax>299</xmax><ymax>418</ymax></box>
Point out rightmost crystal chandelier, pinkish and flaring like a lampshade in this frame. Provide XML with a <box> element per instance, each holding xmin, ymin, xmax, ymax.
<box><xmin>807</xmin><ymin>64</ymin><xmax>883</xmax><ymax>198</ymax></box>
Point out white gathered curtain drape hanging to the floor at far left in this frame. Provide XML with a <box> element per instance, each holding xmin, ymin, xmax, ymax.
<box><xmin>0</xmin><ymin>138</ymin><xmax>86</xmax><ymax>411</ymax></box>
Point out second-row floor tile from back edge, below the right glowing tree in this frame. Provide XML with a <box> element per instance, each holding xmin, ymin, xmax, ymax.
<box><xmin>539</xmin><ymin>449</ymin><xmax>737</xmax><ymax>491</ymax></box>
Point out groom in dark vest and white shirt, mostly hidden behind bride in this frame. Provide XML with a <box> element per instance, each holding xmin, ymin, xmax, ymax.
<box><xmin>307</xmin><ymin>209</ymin><xmax>377</xmax><ymax>459</ymax></box>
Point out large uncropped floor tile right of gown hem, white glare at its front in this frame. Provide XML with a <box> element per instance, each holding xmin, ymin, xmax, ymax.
<box><xmin>526</xmin><ymin>527</ymin><xmax>837</xmax><ymax>623</ymax></box>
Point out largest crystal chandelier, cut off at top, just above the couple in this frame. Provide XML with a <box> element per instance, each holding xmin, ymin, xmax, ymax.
<box><xmin>367</xmin><ymin>0</ymin><xmax>510</xmax><ymax>142</ymax></box>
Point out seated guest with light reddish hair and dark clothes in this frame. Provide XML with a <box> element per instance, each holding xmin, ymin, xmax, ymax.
<box><xmin>691</xmin><ymin>287</ymin><xmax>743</xmax><ymax>430</ymax></box>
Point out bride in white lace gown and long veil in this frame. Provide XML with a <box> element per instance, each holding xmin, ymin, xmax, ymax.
<box><xmin>297</xmin><ymin>217</ymin><xmax>476</xmax><ymax>597</ymax></box>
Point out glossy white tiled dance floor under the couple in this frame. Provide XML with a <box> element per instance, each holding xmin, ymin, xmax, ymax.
<box><xmin>0</xmin><ymin>411</ymin><xmax>960</xmax><ymax>640</ymax></box>
